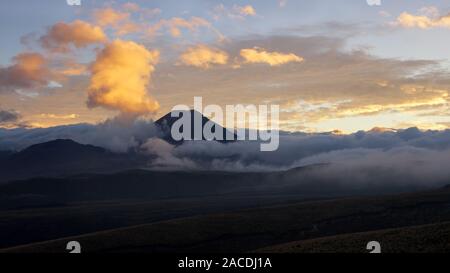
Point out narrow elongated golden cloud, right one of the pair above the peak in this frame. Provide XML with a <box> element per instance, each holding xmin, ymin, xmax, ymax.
<box><xmin>240</xmin><ymin>47</ymin><xmax>304</xmax><ymax>66</ymax></box>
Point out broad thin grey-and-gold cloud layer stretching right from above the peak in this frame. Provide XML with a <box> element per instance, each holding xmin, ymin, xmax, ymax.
<box><xmin>153</xmin><ymin>35</ymin><xmax>450</xmax><ymax>132</ymax></box>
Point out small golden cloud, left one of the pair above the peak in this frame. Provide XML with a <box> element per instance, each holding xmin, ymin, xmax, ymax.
<box><xmin>180</xmin><ymin>45</ymin><xmax>228</xmax><ymax>69</ymax></box>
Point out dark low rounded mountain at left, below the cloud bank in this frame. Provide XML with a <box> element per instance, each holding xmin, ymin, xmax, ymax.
<box><xmin>0</xmin><ymin>139</ymin><xmax>142</xmax><ymax>182</ymax></box>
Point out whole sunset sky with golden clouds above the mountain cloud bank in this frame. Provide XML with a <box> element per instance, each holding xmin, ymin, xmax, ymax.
<box><xmin>0</xmin><ymin>0</ymin><xmax>450</xmax><ymax>133</ymax></box>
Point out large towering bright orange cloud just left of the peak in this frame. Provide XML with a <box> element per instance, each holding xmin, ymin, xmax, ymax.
<box><xmin>88</xmin><ymin>40</ymin><xmax>159</xmax><ymax>115</ymax></box>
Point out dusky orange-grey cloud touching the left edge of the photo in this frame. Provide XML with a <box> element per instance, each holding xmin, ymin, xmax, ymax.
<box><xmin>0</xmin><ymin>52</ymin><xmax>51</xmax><ymax>91</ymax></box>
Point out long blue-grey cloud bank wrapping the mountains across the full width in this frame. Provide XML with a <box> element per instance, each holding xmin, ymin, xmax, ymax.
<box><xmin>4</xmin><ymin>121</ymin><xmax>450</xmax><ymax>191</ymax></box>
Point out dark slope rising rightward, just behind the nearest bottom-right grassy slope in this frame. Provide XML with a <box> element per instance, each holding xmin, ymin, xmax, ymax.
<box><xmin>7</xmin><ymin>189</ymin><xmax>450</xmax><ymax>252</ymax></box>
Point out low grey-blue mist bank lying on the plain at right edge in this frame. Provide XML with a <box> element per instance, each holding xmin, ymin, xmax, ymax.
<box><xmin>297</xmin><ymin>146</ymin><xmax>450</xmax><ymax>188</ymax></box>
